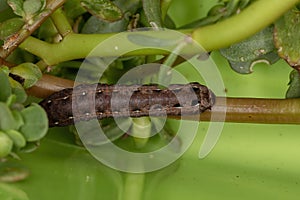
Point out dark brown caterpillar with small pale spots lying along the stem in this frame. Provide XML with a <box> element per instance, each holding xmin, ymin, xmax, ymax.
<box><xmin>40</xmin><ymin>83</ymin><xmax>215</xmax><ymax>127</ymax></box>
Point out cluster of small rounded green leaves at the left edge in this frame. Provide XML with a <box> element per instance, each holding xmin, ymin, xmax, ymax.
<box><xmin>0</xmin><ymin>66</ymin><xmax>48</xmax><ymax>158</ymax></box>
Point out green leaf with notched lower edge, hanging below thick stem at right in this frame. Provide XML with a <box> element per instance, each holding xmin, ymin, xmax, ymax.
<box><xmin>220</xmin><ymin>27</ymin><xmax>279</xmax><ymax>74</ymax></box>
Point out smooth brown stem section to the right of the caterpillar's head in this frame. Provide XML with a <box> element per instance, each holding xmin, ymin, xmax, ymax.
<box><xmin>169</xmin><ymin>97</ymin><xmax>300</xmax><ymax>124</ymax></box>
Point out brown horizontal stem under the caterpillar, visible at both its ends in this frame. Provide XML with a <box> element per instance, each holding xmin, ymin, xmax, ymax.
<box><xmin>27</xmin><ymin>74</ymin><xmax>300</xmax><ymax>124</ymax></box>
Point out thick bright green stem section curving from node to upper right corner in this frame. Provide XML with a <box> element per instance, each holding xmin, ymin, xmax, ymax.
<box><xmin>192</xmin><ymin>0</ymin><xmax>299</xmax><ymax>51</ymax></box>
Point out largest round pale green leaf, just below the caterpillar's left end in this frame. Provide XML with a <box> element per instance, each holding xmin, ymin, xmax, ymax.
<box><xmin>20</xmin><ymin>103</ymin><xmax>48</xmax><ymax>142</ymax></box>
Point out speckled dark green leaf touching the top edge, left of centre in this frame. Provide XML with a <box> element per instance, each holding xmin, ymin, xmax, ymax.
<box><xmin>81</xmin><ymin>0</ymin><xmax>123</xmax><ymax>22</ymax></box>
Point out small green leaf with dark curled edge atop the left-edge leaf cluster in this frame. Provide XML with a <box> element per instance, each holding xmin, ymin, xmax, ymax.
<box><xmin>10</xmin><ymin>63</ymin><xmax>42</xmax><ymax>88</ymax></box>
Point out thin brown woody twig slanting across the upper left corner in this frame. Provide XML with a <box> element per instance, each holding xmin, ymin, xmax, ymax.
<box><xmin>0</xmin><ymin>0</ymin><xmax>65</xmax><ymax>59</ymax></box>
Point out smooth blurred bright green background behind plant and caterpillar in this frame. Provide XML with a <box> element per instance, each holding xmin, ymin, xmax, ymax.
<box><xmin>5</xmin><ymin>0</ymin><xmax>300</xmax><ymax>200</ymax></box>
